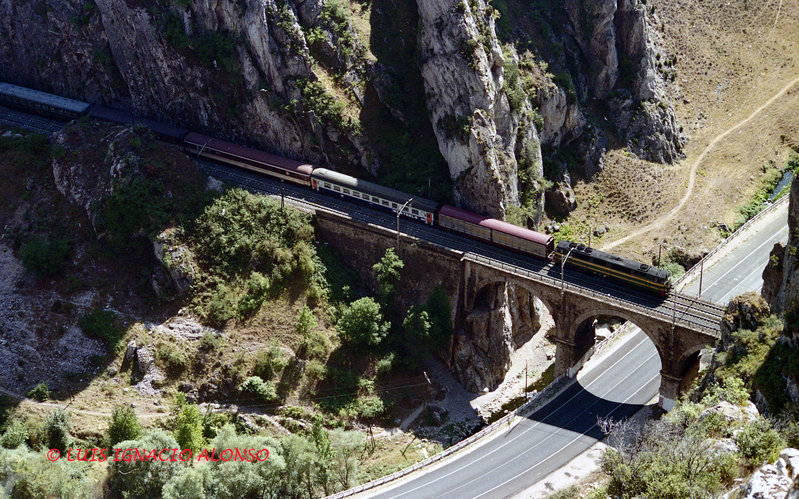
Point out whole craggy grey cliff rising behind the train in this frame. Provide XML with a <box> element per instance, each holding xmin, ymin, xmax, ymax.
<box><xmin>0</xmin><ymin>0</ymin><xmax>682</xmax><ymax>225</ymax></box>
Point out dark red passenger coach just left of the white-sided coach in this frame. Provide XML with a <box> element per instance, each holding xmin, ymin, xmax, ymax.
<box><xmin>184</xmin><ymin>132</ymin><xmax>313</xmax><ymax>187</ymax></box>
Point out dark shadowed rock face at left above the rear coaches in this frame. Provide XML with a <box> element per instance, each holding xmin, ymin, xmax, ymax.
<box><xmin>0</xmin><ymin>0</ymin><xmax>377</xmax><ymax>172</ymax></box>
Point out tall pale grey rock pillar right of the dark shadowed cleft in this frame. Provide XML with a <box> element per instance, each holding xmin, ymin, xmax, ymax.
<box><xmin>418</xmin><ymin>0</ymin><xmax>542</xmax><ymax>218</ymax></box>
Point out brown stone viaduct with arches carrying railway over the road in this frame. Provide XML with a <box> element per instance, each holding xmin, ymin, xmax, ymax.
<box><xmin>315</xmin><ymin>211</ymin><xmax>720</xmax><ymax>409</ymax></box>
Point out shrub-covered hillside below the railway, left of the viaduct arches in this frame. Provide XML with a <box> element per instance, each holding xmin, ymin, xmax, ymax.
<box><xmin>0</xmin><ymin>122</ymin><xmax>452</xmax><ymax>497</ymax></box>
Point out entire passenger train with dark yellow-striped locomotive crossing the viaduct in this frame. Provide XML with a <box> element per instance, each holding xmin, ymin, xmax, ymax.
<box><xmin>0</xmin><ymin>82</ymin><xmax>670</xmax><ymax>296</ymax></box>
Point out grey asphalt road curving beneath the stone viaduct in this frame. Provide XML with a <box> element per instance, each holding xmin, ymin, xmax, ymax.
<box><xmin>364</xmin><ymin>201</ymin><xmax>788</xmax><ymax>499</ymax></box>
